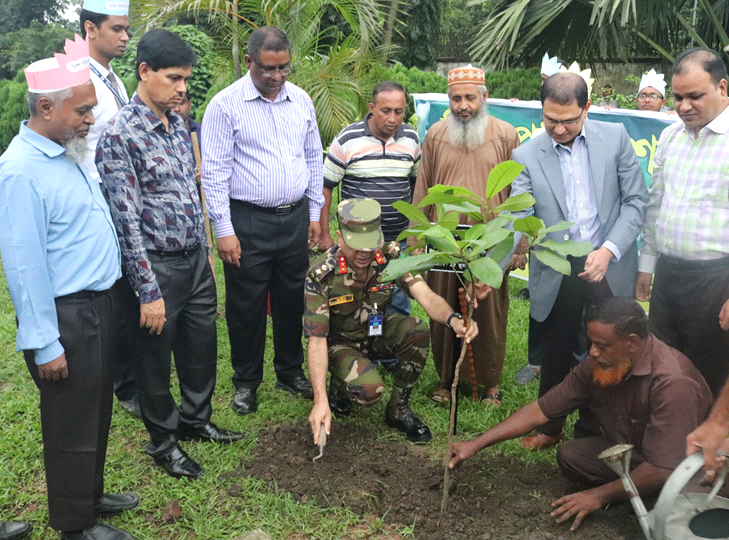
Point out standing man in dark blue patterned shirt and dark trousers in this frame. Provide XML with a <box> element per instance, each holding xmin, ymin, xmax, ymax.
<box><xmin>96</xmin><ymin>29</ymin><xmax>243</xmax><ymax>478</ymax></box>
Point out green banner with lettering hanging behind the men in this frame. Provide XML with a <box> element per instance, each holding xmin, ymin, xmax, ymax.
<box><xmin>413</xmin><ymin>94</ymin><xmax>679</xmax><ymax>184</ymax></box>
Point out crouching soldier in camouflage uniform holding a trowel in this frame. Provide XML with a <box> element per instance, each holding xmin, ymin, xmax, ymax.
<box><xmin>304</xmin><ymin>199</ymin><xmax>478</xmax><ymax>443</ymax></box>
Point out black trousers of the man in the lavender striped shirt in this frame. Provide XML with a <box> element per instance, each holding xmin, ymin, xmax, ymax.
<box><xmin>224</xmin><ymin>199</ymin><xmax>309</xmax><ymax>390</ymax></box>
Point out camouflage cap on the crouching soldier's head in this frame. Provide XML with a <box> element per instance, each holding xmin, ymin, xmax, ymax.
<box><xmin>337</xmin><ymin>199</ymin><xmax>385</xmax><ymax>251</ymax></box>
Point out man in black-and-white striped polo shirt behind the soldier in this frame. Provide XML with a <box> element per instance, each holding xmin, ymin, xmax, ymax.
<box><xmin>319</xmin><ymin>81</ymin><xmax>420</xmax><ymax>315</ymax></box>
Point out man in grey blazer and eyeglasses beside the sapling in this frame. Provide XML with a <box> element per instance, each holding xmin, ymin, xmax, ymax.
<box><xmin>511</xmin><ymin>73</ymin><xmax>648</xmax><ymax>450</ymax></box>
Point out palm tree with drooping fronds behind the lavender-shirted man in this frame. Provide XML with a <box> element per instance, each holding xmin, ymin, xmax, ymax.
<box><xmin>132</xmin><ymin>0</ymin><xmax>387</xmax><ymax>146</ymax></box>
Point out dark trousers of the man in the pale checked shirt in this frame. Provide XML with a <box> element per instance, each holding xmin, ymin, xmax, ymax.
<box><xmin>648</xmin><ymin>255</ymin><xmax>729</xmax><ymax>397</ymax></box>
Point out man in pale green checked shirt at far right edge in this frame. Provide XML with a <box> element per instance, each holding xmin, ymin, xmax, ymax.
<box><xmin>635</xmin><ymin>48</ymin><xmax>729</xmax><ymax>397</ymax></box>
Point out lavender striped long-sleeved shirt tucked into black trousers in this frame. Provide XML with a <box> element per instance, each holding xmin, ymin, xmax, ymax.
<box><xmin>201</xmin><ymin>73</ymin><xmax>324</xmax><ymax>237</ymax></box>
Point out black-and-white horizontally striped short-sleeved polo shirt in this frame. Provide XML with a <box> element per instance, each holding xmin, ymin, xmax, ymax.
<box><xmin>324</xmin><ymin>117</ymin><xmax>420</xmax><ymax>242</ymax></box>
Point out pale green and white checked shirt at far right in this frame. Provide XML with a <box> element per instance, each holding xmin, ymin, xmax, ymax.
<box><xmin>639</xmin><ymin>103</ymin><xmax>729</xmax><ymax>273</ymax></box>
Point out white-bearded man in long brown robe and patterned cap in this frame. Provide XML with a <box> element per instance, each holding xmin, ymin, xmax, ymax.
<box><xmin>413</xmin><ymin>66</ymin><xmax>519</xmax><ymax>405</ymax></box>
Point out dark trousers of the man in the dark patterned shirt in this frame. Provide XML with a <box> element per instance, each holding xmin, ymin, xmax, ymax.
<box><xmin>118</xmin><ymin>247</ymin><xmax>218</xmax><ymax>456</ymax></box>
